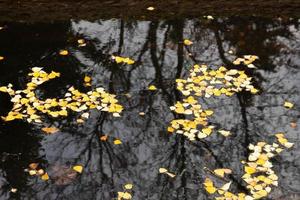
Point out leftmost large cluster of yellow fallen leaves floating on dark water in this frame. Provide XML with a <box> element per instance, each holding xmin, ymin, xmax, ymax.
<box><xmin>0</xmin><ymin>67</ymin><xmax>123</xmax><ymax>123</ymax></box>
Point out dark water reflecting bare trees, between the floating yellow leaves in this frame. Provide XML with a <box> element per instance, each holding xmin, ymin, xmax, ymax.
<box><xmin>0</xmin><ymin>17</ymin><xmax>300</xmax><ymax>200</ymax></box>
